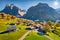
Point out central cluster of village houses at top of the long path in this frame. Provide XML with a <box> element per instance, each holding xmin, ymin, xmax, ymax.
<box><xmin>28</xmin><ymin>22</ymin><xmax>46</xmax><ymax>34</ymax></box>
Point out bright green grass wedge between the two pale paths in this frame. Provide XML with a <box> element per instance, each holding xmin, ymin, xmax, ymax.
<box><xmin>24</xmin><ymin>31</ymin><xmax>49</xmax><ymax>40</ymax></box>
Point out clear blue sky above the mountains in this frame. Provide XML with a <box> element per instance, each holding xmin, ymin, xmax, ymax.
<box><xmin>0</xmin><ymin>0</ymin><xmax>60</xmax><ymax>11</ymax></box>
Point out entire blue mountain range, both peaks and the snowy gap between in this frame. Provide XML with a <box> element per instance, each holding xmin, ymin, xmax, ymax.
<box><xmin>1</xmin><ymin>3</ymin><xmax>60</xmax><ymax>21</ymax></box>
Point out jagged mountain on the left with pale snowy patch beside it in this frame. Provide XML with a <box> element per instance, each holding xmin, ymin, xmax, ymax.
<box><xmin>1</xmin><ymin>4</ymin><xmax>26</xmax><ymax>17</ymax></box>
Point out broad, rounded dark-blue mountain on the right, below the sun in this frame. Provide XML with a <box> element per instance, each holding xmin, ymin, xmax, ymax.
<box><xmin>24</xmin><ymin>3</ymin><xmax>60</xmax><ymax>21</ymax></box>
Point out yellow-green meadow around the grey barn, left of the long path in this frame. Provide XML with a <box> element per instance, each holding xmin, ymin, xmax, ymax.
<box><xmin>0</xmin><ymin>21</ymin><xmax>27</xmax><ymax>40</ymax></box>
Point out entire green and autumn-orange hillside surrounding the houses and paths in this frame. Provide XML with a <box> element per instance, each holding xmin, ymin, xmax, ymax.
<box><xmin>0</xmin><ymin>13</ymin><xmax>60</xmax><ymax>40</ymax></box>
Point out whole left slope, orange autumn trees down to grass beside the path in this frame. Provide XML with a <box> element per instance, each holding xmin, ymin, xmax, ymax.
<box><xmin>0</xmin><ymin>13</ymin><xmax>27</xmax><ymax>40</ymax></box>
